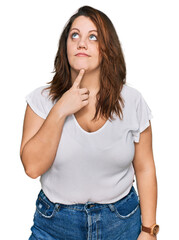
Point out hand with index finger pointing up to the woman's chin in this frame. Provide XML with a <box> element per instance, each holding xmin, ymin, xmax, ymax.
<box><xmin>55</xmin><ymin>69</ymin><xmax>89</xmax><ymax>116</ymax></box>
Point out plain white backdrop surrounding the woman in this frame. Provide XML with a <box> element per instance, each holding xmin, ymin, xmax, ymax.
<box><xmin>0</xmin><ymin>0</ymin><xmax>179</xmax><ymax>240</ymax></box>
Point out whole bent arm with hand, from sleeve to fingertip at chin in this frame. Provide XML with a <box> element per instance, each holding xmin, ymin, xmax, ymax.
<box><xmin>20</xmin><ymin>69</ymin><xmax>89</xmax><ymax>178</ymax></box>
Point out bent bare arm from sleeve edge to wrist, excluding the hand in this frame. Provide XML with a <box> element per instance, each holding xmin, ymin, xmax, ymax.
<box><xmin>20</xmin><ymin>102</ymin><xmax>65</xmax><ymax>178</ymax></box>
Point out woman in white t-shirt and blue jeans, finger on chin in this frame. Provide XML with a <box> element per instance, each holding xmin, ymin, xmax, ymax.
<box><xmin>20</xmin><ymin>6</ymin><xmax>158</xmax><ymax>240</ymax></box>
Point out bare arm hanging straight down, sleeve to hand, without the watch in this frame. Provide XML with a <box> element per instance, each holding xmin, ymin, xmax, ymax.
<box><xmin>133</xmin><ymin>122</ymin><xmax>157</xmax><ymax>240</ymax></box>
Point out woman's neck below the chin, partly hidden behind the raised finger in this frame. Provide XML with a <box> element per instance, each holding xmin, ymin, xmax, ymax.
<box><xmin>71</xmin><ymin>69</ymin><xmax>100</xmax><ymax>95</ymax></box>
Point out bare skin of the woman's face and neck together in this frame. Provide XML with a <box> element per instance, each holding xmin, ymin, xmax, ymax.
<box><xmin>67</xmin><ymin>16</ymin><xmax>101</xmax><ymax>96</ymax></box>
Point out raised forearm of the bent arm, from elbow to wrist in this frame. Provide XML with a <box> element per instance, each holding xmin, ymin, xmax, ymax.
<box><xmin>22</xmin><ymin>106</ymin><xmax>65</xmax><ymax>178</ymax></box>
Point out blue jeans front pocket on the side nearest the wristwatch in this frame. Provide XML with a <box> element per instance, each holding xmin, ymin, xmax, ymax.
<box><xmin>114</xmin><ymin>188</ymin><xmax>140</xmax><ymax>219</ymax></box>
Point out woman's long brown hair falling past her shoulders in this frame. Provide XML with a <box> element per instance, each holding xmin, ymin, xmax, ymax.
<box><xmin>44</xmin><ymin>6</ymin><xmax>126</xmax><ymax>120</ymax></box>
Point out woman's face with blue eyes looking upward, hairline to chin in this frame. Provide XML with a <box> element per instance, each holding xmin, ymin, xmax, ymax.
<box><xmin>67</xmin><ymin>16</ymin><xmax>100</xmax><ymax>71</ymax></box>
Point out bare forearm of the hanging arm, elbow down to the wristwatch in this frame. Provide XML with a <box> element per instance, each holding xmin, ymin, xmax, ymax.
<box><xmin>136</xmin><ymin>168</ymin><xmax>157</xmax><ymax>227</ymax></box>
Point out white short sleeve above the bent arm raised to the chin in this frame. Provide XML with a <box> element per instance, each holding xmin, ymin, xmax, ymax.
<box><xmin>25</xmin><ymin>86</ymin><xmax>47</xmax><ymax>119</ymax></box>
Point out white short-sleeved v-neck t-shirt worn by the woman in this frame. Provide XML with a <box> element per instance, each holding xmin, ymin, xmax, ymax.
<box><xmin>25</xmin><ymin>84</ymin><xmax>153</xmax><ymax>204</ymax></box>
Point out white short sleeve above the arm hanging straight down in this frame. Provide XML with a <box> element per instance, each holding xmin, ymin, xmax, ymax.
<box><xmin>132</xmin><ymin>93</ymin><xmax>153</xmax><ymax>143</ymax></box>
